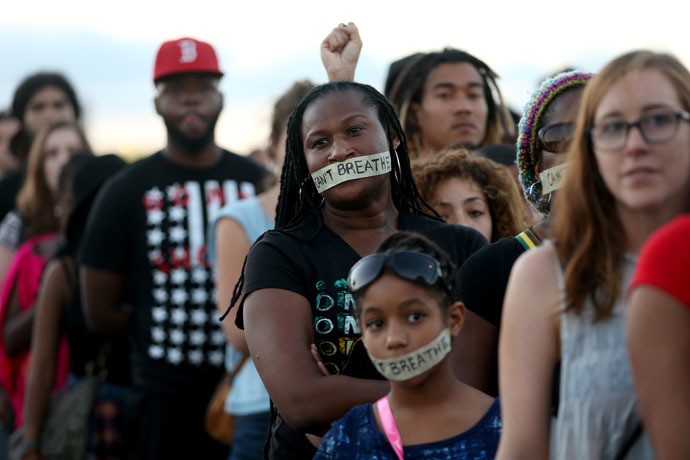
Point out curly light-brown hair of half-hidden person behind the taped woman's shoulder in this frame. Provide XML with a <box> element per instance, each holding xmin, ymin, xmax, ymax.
<box><xmin>413</xmin><ymin>148</ymin><xmax>531</xmax><ymax>242</ymax></box>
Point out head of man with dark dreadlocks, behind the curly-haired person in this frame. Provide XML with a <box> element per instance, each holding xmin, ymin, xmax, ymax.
<box><xmin>387</xmin><ymin>48</ymin><xmax>515</xmax><ymax>158</ymax></box>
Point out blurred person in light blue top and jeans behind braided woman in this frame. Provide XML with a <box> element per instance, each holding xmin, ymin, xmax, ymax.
<box><xmin>209</xmin><ymin>80</ymin><xmax>315</xmax><ymax>460</ymax></box>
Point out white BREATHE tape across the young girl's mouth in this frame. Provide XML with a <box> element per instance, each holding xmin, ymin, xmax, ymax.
<box><xmin>367</xmin><ymin>328</ymin><xmax>450</xmax><ymax>380</ymax></box>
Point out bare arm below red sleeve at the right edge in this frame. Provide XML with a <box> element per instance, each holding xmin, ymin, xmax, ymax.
<box><xmin>626</xmin><ymin>286</ymin><xmax>690</xmax><ymax>459</ymax></box>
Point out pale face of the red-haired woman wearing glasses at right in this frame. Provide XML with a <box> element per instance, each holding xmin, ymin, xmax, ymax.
<box><xmin>593</xmin><ymin>68</ymin><xmax>690</xmax><ymax>211</ymax></box>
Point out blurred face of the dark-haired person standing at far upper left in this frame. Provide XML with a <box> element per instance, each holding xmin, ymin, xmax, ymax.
<box><xmin>24</xmin><ymin>86</ymin><xmax>76</xmax><ymax>136</ymax></box>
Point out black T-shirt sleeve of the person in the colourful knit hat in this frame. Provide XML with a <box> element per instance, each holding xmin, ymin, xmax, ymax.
<box><xmin>458</xmin><ymin>237</ymin><xmax>525</xmax><ymax>329</ymax></box>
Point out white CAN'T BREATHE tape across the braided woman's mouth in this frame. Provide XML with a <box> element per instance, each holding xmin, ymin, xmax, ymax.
<box><xmin>311</xmin><ymin>151</ymin><xmax>391</xmax><ymax>193</ymax></box>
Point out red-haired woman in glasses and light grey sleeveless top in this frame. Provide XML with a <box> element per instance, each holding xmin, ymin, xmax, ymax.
<box><xmin>499</xmin><ymin>51</ymin><xmax>690</xmax><ymax>459</ymax></box>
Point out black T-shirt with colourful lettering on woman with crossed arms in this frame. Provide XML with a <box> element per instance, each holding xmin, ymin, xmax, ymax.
<box><xmin>237</xmin><ymin>212</ymin><xmax>487</xmax><ymax>458</ymax></box>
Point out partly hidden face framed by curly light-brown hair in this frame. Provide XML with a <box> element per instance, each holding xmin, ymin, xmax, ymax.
<box><xmin>431</xmin><ymin>177</ymin><xmax>493</xmax><ymax>241</ymax></box>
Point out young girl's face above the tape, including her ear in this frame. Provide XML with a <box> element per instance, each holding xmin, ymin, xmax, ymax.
<box><xmin>357</xmin><ymin>272</ymin><xmax>463</xmax><ymax>380</ymax></box>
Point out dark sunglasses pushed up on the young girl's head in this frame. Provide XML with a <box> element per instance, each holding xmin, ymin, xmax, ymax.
<box><xmin>347</xmin><ymin>251</ymin><xmax>450</xmax><ymax>295</ymax></box>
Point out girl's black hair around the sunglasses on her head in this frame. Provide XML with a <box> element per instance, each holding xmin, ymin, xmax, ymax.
<box><xmin>352</xmin><ymin>232</ymin><xmax>455</xmax><ymax>314</ymax></box>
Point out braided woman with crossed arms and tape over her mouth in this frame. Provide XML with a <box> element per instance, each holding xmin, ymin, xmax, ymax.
<box><xmin>224</xmin><ymin>81</ymin><xmax>486</xmax><ymax>459</ymax></box>
